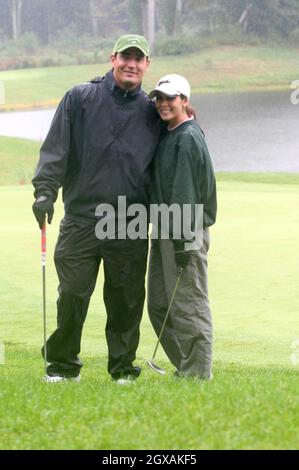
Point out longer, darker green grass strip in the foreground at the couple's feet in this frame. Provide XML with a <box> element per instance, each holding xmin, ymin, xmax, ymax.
<box><xmin>0</xmin><ymin>347</ymin><xmax>299</xmax><ymax>449</ymax></box>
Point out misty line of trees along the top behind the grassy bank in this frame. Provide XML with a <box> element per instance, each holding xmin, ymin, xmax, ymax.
<box><xmin>0</xmin><ymin>0</ymin><xmax>299</xmax><ymax>45</ymax></box>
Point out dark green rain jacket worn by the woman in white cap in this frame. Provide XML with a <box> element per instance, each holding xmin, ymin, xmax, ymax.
<box><xmin>151</xmin><ymin>120</ymin><xmax>217</xmax><ymax>250</ymax></box>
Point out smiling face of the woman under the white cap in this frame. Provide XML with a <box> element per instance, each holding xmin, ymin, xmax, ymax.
<box><xmin>156</xmin><ymin>93</ymin><xmax>188</xmax><ymax>127</ymax></box>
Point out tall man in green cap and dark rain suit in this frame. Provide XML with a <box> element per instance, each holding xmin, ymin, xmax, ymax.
<box><xmin>32</xmin><ymin>34</ymin><xmax>160</xmax><ymax>384</ymax></box>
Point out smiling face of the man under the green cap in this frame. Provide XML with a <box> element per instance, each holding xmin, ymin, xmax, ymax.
<box><xmin>111</xmin><ymin>47</ymin><xmax>150</xmax><ymax>90</ymax></box>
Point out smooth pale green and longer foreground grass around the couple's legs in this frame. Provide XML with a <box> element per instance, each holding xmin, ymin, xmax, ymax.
<box><xmin>0</xmin><ymin>175</ymin><xmax>299</xmax><ymax>449</ymax></box>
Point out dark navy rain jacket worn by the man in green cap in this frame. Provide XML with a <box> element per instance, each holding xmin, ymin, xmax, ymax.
<box><xmin>32</xmin><ymin>71</ymin><xmax>161</xmax><ymax>221</ymax></box>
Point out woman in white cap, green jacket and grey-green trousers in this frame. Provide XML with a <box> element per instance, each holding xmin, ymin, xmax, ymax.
<box><xmin>148</xmin><ymin>74</ymin><xmax>217</xmax><ymax>379</ymax></box>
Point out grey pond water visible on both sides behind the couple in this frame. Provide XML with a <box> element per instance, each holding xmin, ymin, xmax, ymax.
<box><xmin>0</xmin><ymin>92</ymin><xmax>299</xmax><ymax>173</ymax></box>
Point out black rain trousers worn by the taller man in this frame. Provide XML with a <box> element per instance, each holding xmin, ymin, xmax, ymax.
<box><xmin>43</xmin><ymin>218</ymin><xmax>148</xmax><ymax>379</ymax></box>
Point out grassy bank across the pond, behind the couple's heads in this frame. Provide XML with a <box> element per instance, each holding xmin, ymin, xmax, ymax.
<box><xmin>0</xmin><ymin>46</ymin><xmax>299</xmax><ymax>109</ymax></box>
